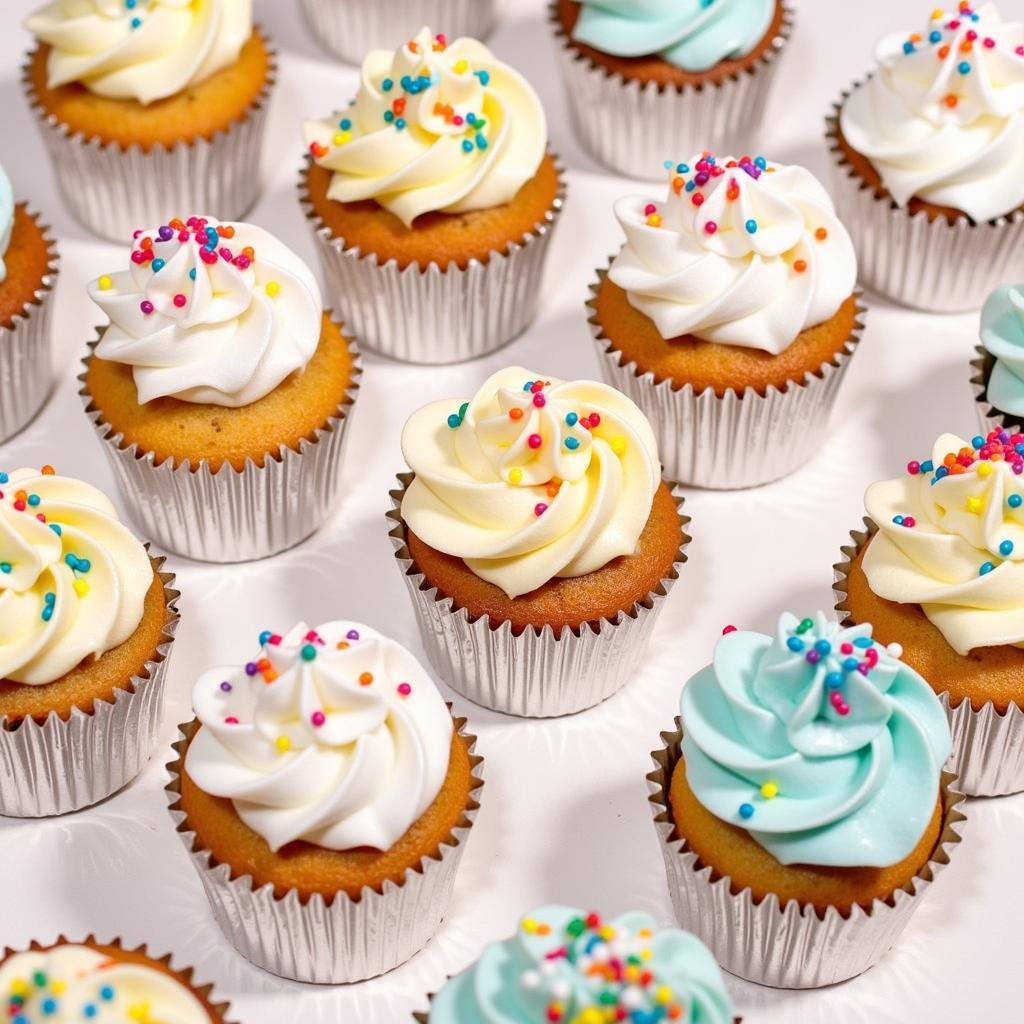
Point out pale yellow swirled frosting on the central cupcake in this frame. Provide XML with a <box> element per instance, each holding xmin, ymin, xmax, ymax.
<box><xmin>401</xmin><ymin>367</ymin><xmax>660</xmax><ymax>597</ymax></box>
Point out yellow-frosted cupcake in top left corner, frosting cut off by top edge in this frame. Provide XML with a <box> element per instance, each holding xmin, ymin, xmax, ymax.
<box><xmin>23</xmin><ymin>0</ymin><xmax>275</xmax><ymax>242</ymax></box>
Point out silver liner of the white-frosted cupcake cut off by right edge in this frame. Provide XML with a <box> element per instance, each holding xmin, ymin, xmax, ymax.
<box><xmin>825</xmin><ymin>88</ymin><xmax>1024</xmax><ymax>312</ymax></box>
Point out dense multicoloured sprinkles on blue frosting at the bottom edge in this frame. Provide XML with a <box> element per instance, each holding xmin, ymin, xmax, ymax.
<box><xmin>519</xmin><ymin>913</ymin><xmax>686</xmax><ymax>1024</ymax></box>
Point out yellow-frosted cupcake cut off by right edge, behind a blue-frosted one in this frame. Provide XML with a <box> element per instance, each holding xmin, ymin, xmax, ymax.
<box><xmin>836</xmin><ymin>430</ymin><xmax>1024</xmax><ymax>796</ymax></box>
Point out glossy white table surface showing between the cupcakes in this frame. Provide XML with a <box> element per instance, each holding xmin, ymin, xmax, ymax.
<box><xmin>0</xmin><ymin>0</ymin><xmax>1024</xmax><ymax>1024</ymax></box>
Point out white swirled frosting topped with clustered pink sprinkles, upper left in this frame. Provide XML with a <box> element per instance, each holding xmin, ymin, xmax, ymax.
<box><xmin>89</xmin><ymin>217</ymin><xmax>324</xmax><ymax>408</ymax></box>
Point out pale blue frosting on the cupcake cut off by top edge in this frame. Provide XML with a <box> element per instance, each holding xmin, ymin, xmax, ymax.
<box><xmin>572</xmin><ymin>0</ymin><xmax>775</xmax><ymax>72</ymax></box>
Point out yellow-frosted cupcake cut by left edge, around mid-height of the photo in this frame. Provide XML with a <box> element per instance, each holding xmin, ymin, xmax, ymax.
<box><xmin>0</xmin><ymin>466</ymin><xmax>178</xmax><ymax>815</ymax></box>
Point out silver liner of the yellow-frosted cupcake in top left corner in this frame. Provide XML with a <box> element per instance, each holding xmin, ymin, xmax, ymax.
<box><xmin>22</xmin><ymin>39</ymin><xmax>276</xmax><ymax>242</ymax></box>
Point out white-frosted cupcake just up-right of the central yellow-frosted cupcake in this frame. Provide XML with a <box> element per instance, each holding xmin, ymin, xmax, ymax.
<box><xmin>588</xmin><ymin>153</ymin><xmax>864</xmax><ymax>487</ymax></box>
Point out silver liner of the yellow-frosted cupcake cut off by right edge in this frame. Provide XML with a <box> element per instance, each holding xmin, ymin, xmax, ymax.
<box><xmin>833</xmin><ymin>516</ymin><xmax>1024</xmax><ymax>797</ymax></box>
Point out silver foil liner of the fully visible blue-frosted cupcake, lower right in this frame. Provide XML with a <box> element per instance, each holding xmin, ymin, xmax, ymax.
<box><xmin>647</xmin><ymin>718</ymin><xmax>966</xmax><ymax>988</ymax></box>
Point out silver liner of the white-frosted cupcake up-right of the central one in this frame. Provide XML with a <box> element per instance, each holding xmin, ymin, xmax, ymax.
<box><xmin>587</xmin><ymin>270</ymin><xmax>867</xmax><ymax>489</ymax></box>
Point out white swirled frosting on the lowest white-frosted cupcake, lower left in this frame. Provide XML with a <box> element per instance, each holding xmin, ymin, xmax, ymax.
<box><xmin>185</xmin><ymin>622</ymin><xmax>454</xmax><ymax>851</ymax></box>
